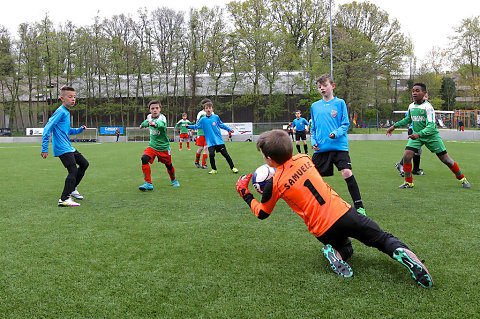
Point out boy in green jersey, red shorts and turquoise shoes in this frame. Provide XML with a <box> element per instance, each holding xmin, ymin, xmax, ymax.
<box><xmin>138</xmin><ymin>100</ymin><xmax>180</xmax><ymax>191</ymax></box>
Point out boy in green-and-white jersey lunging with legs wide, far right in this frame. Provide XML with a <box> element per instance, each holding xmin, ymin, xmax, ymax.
<box><xmin>387</xmin><ymin>83</ymin><xmax>471</xmax><ymax>188</ymax></box>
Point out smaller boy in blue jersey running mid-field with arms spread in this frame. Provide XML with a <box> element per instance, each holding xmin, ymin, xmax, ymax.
<box><xmin>188</xmin><ymin>101</ymin><xmax>238</xmax><ymax>174</ymax></box>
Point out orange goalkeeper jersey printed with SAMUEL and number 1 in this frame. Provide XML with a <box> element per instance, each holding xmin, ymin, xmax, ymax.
<box><xmin>250</xmin><ymin>154</ymin><xmax>351</xmax><ymax>237</ymax></box>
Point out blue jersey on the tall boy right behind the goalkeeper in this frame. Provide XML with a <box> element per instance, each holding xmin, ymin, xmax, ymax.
<box><xmin>310</xmin><ymin>97</ymin><xmax>350</xmax><ymax>153</ymax></box>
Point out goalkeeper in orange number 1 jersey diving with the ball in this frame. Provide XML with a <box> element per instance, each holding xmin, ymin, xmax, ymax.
<box><xmin>236</xmin><ymin>130</ymin><xmax>433</xmax><ymax>288</ymax></box>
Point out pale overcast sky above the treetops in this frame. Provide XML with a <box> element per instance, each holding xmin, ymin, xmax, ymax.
<box><xmin>0</xmin><ymin>0</ymin><xmax>480</xmax><ymax>60</ymax></box>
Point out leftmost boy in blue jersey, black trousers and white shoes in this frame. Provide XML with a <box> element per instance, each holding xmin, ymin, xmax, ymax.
<box><xmin>41</xmin><ymin>86</ymin><xmax>89</xmax><ymax>207</ymax></box>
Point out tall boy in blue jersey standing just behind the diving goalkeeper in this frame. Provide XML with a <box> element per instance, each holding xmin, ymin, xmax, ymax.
<box><xmin>310</xmin><ymin>74</ymin><xmax>365</xmax><ymax>214</ymax></box>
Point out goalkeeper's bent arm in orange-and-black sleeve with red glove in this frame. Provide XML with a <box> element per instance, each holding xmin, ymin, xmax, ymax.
<box><xmin>236</xmin><ymin>174</ymin><xmax>279</xmax><ymax>219</ymax></box>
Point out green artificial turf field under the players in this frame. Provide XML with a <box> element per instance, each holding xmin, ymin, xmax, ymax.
<box><xmin>0</xmin><ymin>141</ymin><xmax>480</xmax><ymax>318</ymax></box>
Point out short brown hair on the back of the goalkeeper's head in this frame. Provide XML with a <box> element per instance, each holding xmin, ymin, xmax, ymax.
<box><xmin>257</xmin><ymin>130</ymin><xmax>293</xmax><ymax>165</ymax></box>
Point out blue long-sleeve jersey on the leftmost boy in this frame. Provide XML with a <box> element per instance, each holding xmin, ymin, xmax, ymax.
<box><xmin>42</xmin><ymin>105</ymin><xmax>83</xmax><ymax>156</ymax></box>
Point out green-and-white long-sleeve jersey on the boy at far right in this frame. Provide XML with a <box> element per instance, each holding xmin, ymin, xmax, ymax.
<box><xmin>395</xmin><ymin>101</ymin><xmax>438</xmax><ymax>139</ymax></box>
